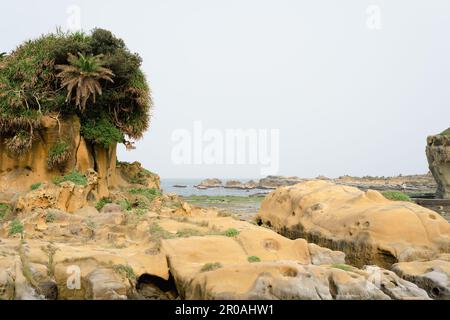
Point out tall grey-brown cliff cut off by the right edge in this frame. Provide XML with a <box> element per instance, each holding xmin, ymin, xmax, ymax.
<box><xmin>426</xmin><ymin>135</ymin><xmax>450</xmax><ymax>199</ymax></box>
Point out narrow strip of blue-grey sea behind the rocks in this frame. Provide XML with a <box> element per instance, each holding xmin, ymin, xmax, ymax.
<box><xmin>161</xmin><ymin>179</ymin><xmax>272</xmax><ymax>197</ymax></box>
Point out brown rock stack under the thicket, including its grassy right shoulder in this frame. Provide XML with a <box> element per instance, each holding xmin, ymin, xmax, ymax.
<box><xmin>0</xmin><ymin>116</ymin><xmax>159</xmax><ymax>199</ymax></box>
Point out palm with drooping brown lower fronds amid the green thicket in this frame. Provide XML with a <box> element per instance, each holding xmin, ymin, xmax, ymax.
<box><xmin>56</xmin><ymin>53</ymin><xmax>114</xmax><ymax>112</ymax></box>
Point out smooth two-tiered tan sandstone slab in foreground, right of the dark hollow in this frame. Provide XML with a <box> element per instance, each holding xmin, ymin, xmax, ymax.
<box><xmin>163</xmin><ymin>232</ymin><xmax>428</xmax><ymax>300</ymax></box>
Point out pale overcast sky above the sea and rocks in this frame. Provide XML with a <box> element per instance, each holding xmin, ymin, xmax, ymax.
<box><xmin>0</xmin><ymin>0</ymin><xmax>450</xmax><ymax>178</ymax></box>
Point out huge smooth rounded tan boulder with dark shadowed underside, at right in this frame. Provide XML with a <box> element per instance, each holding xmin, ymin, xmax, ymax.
<box><xmin>257</xmin><ymin>181</ymin><xmax>450</xmax><ymax>267</ymax></box>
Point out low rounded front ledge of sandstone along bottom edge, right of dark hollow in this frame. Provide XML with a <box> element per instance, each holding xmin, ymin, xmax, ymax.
<box><xmin>182</xmin><ymin>261</ymin><xmax>429</xmax><ymax>300</ymax></box>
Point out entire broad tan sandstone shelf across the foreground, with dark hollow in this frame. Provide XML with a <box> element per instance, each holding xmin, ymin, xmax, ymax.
<box><xmin>0</xmin><ymin>188</ymin><xmax>428</xmax><ymax>299</ymax></box>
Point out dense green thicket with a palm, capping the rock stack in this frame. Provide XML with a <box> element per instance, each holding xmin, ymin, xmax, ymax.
<box><xmin>0</xmin><ymin>29</ymin><xmax>152</xmax><ymax>156</ymax></box>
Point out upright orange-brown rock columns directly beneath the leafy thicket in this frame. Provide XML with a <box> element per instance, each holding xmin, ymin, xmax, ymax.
<box><xmin>0</xmin><ymin>116</ymin><xmax>116</xmax><ymax>197</ymax></box>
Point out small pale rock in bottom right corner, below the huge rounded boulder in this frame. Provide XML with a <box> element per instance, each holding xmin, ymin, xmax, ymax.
<box><xmin>392</xmin><ymin>253</ymin><xmax>450</xmax><ymax>300</ymax></box>
